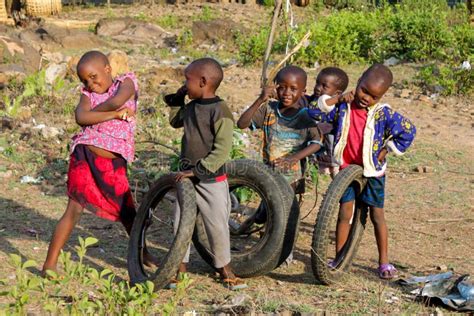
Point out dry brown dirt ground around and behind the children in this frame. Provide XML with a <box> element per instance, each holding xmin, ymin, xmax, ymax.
<box><xmin>0</xmin><ymin>4</ymin><xmax>474</xmax><ymax>314</ymax></box>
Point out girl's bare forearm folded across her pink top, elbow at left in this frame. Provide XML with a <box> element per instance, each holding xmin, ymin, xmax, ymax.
<box><xmin>75</xmin><ymin>94</ymin><xmax>133</xmax><ymax>126</ymax></box>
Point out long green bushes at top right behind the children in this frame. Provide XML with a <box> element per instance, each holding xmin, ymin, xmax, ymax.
<box><xmin>237</xmin><ymin>0</ymin><xmax>474</xmax><ymax>65</ymax></box>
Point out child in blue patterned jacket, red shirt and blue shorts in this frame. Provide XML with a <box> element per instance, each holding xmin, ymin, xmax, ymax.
<box><xmin>309</xmin><ymin>64</ymin><xmax>416</xmax><ymax>279</ymax></box>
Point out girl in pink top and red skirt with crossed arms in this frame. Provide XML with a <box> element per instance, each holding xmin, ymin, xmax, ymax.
<box><xmin>43</xmin><ymin>51</ymin><xmax>154</xmax><ymax>274</ymax></box>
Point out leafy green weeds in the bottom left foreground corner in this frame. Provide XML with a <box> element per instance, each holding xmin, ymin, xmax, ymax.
<box><xmin>0</xmin><ymin>237</ymin><xmax>192</xmax><ymax>315</ymax></box>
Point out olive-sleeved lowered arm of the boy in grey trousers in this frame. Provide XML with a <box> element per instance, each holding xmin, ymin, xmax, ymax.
<box><xmin>193</xmin><ymin>107</ymin><xmax>234</xmax><ymax>178</ymax></box>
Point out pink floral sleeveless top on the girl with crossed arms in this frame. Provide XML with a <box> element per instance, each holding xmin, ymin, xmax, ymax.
<box><xmin>71</xmin><ymin>72</ymin><xmax>138</xmax><ymax>162</ymax></box>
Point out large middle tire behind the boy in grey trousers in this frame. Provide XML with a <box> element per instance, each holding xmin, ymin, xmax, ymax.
<box><xmin>193</xmin><ymin>159</ymin><xmax>292</xmax><ymax>277</ymax></box>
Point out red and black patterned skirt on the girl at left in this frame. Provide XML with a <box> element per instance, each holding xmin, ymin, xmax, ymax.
<box><xmin>67</xmin><ymin>144</ymin><xmax>136</xmax><ymax>222</ymax></box>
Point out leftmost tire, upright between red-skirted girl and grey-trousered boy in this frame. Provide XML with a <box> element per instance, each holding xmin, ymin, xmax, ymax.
<box><xmin>128</xmin><ymin>174</ymin><xmax>197</xmax><ymax>288</ymax></box>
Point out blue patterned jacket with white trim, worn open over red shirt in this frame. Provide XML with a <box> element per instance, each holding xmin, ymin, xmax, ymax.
<box><xmin>309</xmin><ymin>103</ymin><xmax>416</xmax><ymax>177</ymax></box>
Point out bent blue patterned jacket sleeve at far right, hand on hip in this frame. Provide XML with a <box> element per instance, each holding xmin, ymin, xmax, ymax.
<box><xmin>384</xmin><ymin>109</ymin><xmax>416</xmax><ymax>155</ymax></box>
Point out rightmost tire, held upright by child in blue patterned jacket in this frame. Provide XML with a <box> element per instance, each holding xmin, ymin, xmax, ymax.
<box><xmin>311</xmin><ymin>165</ymin><xmax>367</xmax><ymax>285</ymax></box>
